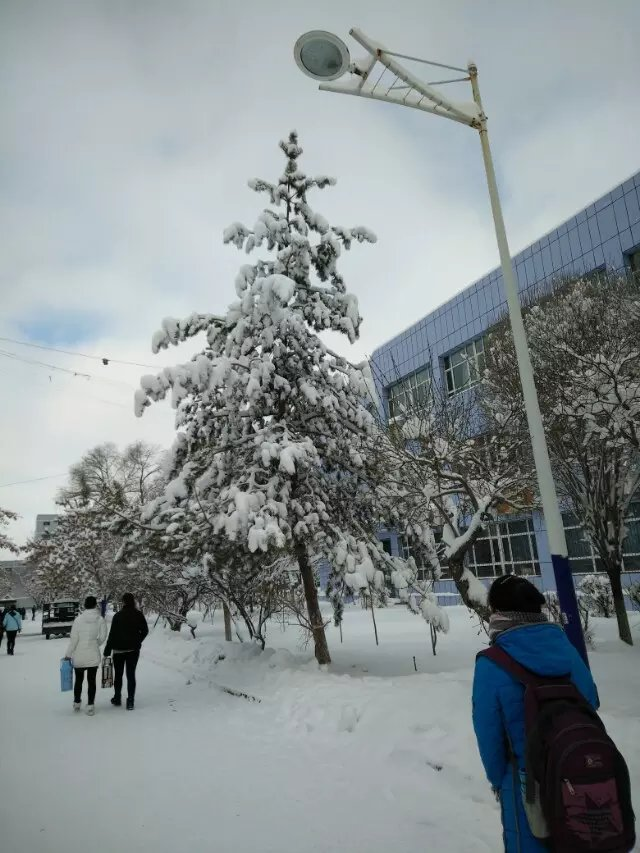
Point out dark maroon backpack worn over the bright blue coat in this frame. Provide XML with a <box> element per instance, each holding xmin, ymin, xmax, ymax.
<box><xmin>478</xmin><ymin>646</ymin><xmax>635</xmax><ymax>853</ymax></box>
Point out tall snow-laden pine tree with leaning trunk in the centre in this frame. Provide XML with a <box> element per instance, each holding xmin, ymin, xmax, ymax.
<box><xmin>136</xmin><ymin>132</ymin><xmax>390</xmax><ymax>664</ymax></box>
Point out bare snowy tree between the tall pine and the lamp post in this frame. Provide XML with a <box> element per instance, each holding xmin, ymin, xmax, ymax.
<box><xmin>381</xmin><ymin>370</ymin><xmax>531</xmax><ymax>620</ymax></box>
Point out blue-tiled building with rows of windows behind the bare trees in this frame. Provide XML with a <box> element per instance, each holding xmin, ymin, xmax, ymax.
<box><xmin>372</xmin><ymin>172</ymin><xmax>640</xmax><ymax>603</ymax></box>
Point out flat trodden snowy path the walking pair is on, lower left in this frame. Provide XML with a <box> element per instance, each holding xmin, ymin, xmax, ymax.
<box><xmin>0</xmin><ymin>620</ymin><xmax>490</xmax><ymax>853</ymax></box>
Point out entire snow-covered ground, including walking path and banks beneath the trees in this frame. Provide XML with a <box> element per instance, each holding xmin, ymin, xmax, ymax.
<box><xmin>0</xmin><ymin>607</ymin><xmax>640</xmax><ymax>853</ymax></box>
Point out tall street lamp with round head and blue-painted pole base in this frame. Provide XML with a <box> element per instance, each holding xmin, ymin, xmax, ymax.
<box><xmin>294</xmin><ymin>29</ymin><xmax>588</xmax><ymax>664</ymax></box>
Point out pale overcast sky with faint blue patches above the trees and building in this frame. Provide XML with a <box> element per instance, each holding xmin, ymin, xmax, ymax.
<box><xmin>0</xmin><ymin>0</ymin><xmax>640</xmax><ymax>556</ymax></box>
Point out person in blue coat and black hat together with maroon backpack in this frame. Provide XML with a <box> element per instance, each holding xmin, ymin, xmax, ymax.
<box><xmin>473</xmin><ymin>575</ymin><xmax>634</xmax><ymax>853</ymax></box>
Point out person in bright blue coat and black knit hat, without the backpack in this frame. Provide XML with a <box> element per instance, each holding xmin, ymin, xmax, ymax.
<box><xmin>473</xmin><ymin>575</ymin><xmax>599</xmax><ymax>853</ymax></box>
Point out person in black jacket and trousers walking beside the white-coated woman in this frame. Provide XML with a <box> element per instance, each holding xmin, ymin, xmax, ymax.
<box><xmin>104</xmin><ymin>592</ymin><xmax>149</xmax><ymax>711</ymax></box>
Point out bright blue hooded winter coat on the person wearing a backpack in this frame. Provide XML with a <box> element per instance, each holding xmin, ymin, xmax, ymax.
<box><xmin>473</xmin><ymin>623</ymin><xmax>599</xmax><ymax>853</ymax></box>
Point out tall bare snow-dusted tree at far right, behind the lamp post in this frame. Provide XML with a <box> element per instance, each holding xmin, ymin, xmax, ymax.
<box><xmin>485</xmin><ymin>274</ymin><xmax>640</xmax><ymax>645</ymax></box>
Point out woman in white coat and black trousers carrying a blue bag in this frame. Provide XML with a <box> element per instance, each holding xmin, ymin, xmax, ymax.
<box><xmin>66</xmin><ymin>595</ymin><xmax>107</xmax><ymax>716</ymax></box>
